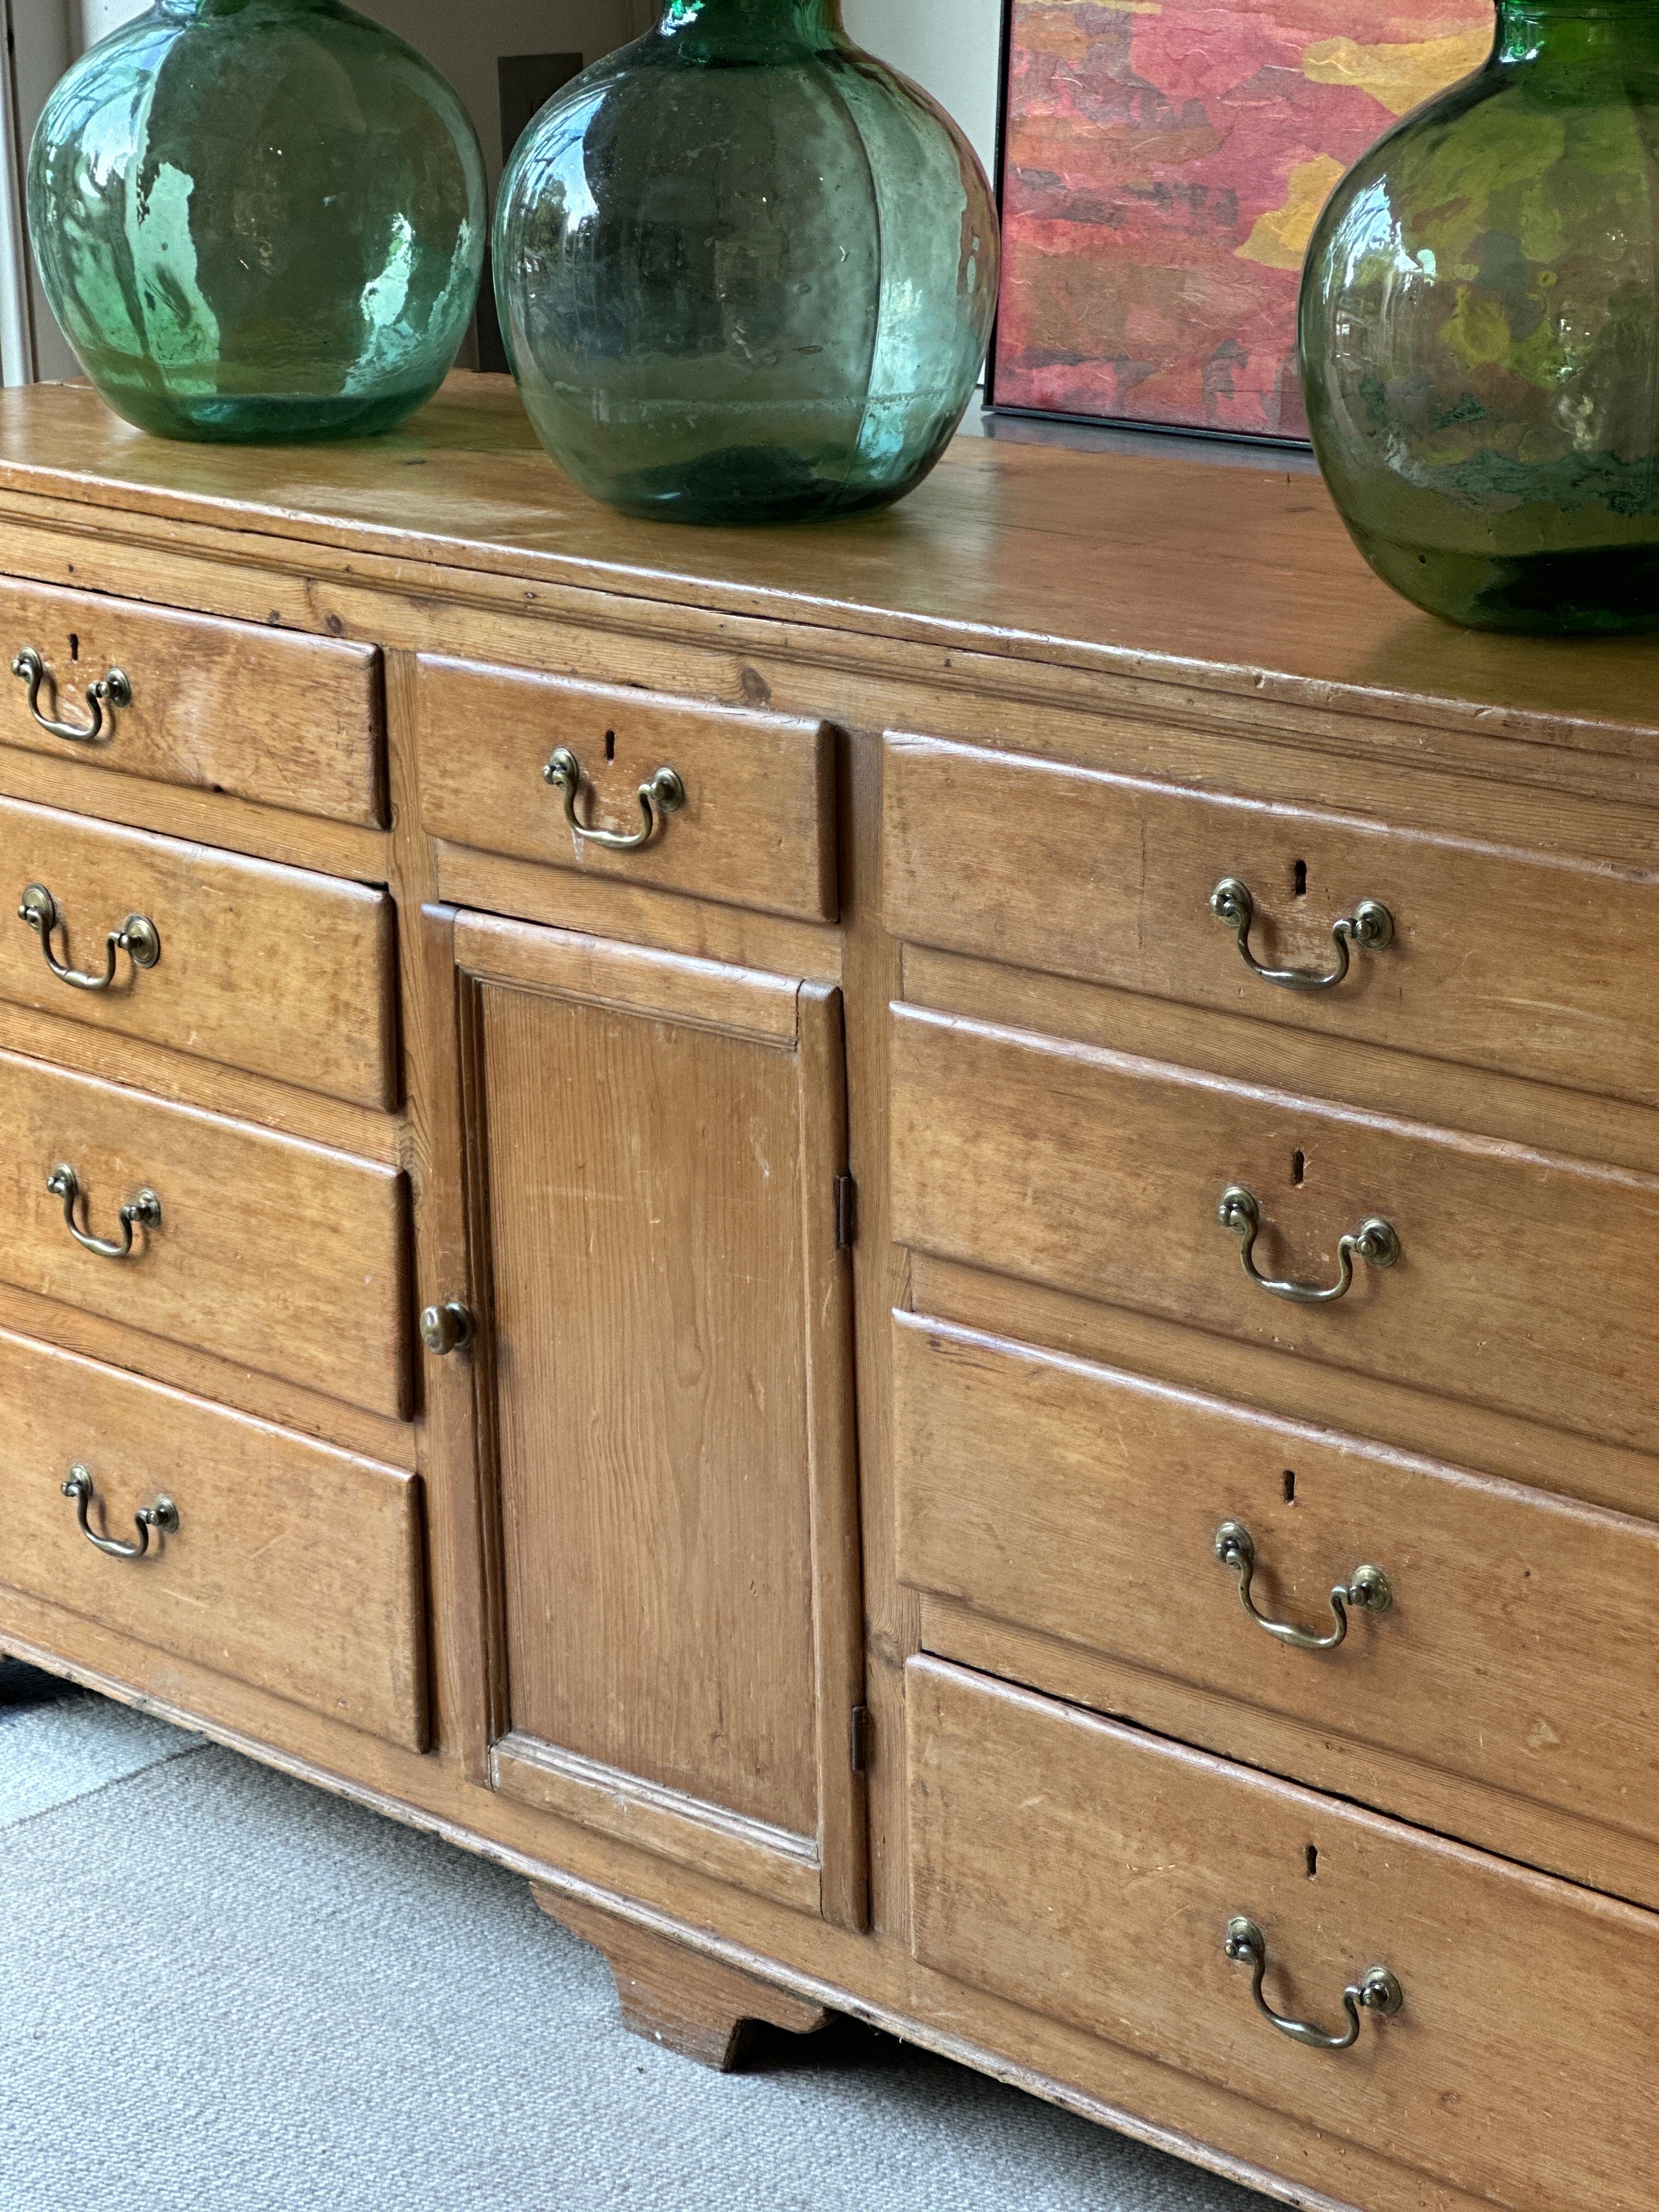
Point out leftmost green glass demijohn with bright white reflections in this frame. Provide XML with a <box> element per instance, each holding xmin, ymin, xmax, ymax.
<box><xmin>29</xmin><ymin>0</ymin><xmax>487</xmax><ymax>442</ymax></box>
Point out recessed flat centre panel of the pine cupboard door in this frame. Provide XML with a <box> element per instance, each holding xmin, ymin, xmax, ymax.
<box><xmin>484</xmin><ymin>991</ymin><xmax>819</xmax><ymax>1834</ymax></box>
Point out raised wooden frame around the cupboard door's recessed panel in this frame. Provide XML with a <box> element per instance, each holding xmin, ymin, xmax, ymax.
<box><xmin>420</xmin><ymin>907</ymin><xmax>870</xmax><ymax>1931</ymax></box>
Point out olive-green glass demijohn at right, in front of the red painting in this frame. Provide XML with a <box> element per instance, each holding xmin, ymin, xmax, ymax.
<box><xmin>1301</xmin><ymin>0</ymin><xmax>1659</xmax><ymax>633</ymax></box>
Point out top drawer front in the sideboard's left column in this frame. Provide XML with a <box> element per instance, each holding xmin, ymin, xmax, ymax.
<box><xmin>0</xmin><ymin>577</ymin><xmax>385</xmax><ymax>827</ymax></box>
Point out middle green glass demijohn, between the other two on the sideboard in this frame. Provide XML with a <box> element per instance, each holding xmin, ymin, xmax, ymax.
<box><xmin>495</xmin><ymin>0</ymin><xmax>1000</xmax><ymax>522</ymax></box>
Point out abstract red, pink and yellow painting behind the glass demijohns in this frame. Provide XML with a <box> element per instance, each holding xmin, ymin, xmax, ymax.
<box><xmin>991</xmin><ymin>0</ymin><xmax>1493</xmax><ymax>438</ymax></box>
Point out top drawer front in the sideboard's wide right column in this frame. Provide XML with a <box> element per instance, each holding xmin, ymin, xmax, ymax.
<box><xmin>885</xmin><ymin>737</ymin><xmax>1659</xmax><ymax>1104</ymax></box>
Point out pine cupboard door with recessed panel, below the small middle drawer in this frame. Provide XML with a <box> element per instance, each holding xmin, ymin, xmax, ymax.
<box><xmin>442</xmin><ymin>916</ymin><xmax>865</xmax><ymax>1927</ymax></box>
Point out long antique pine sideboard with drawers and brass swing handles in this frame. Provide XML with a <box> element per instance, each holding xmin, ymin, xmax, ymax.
<box><xmin>0</xmin><ymin>378</ymin><xmax>1659</xmax><ymax>2212</ymax></box>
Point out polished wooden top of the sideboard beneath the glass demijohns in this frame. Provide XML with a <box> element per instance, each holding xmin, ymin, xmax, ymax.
<box><xmin>0</xmin><ymin>374</ymin><xmax>1659</xmax><ymax>763</ymax></box>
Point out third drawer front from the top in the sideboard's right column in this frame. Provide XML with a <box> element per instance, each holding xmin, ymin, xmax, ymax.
<box><xmin>894</xmin><ymin>1314</ymin><xmax>1659</xmax><ymax>1843</ymax></box>
